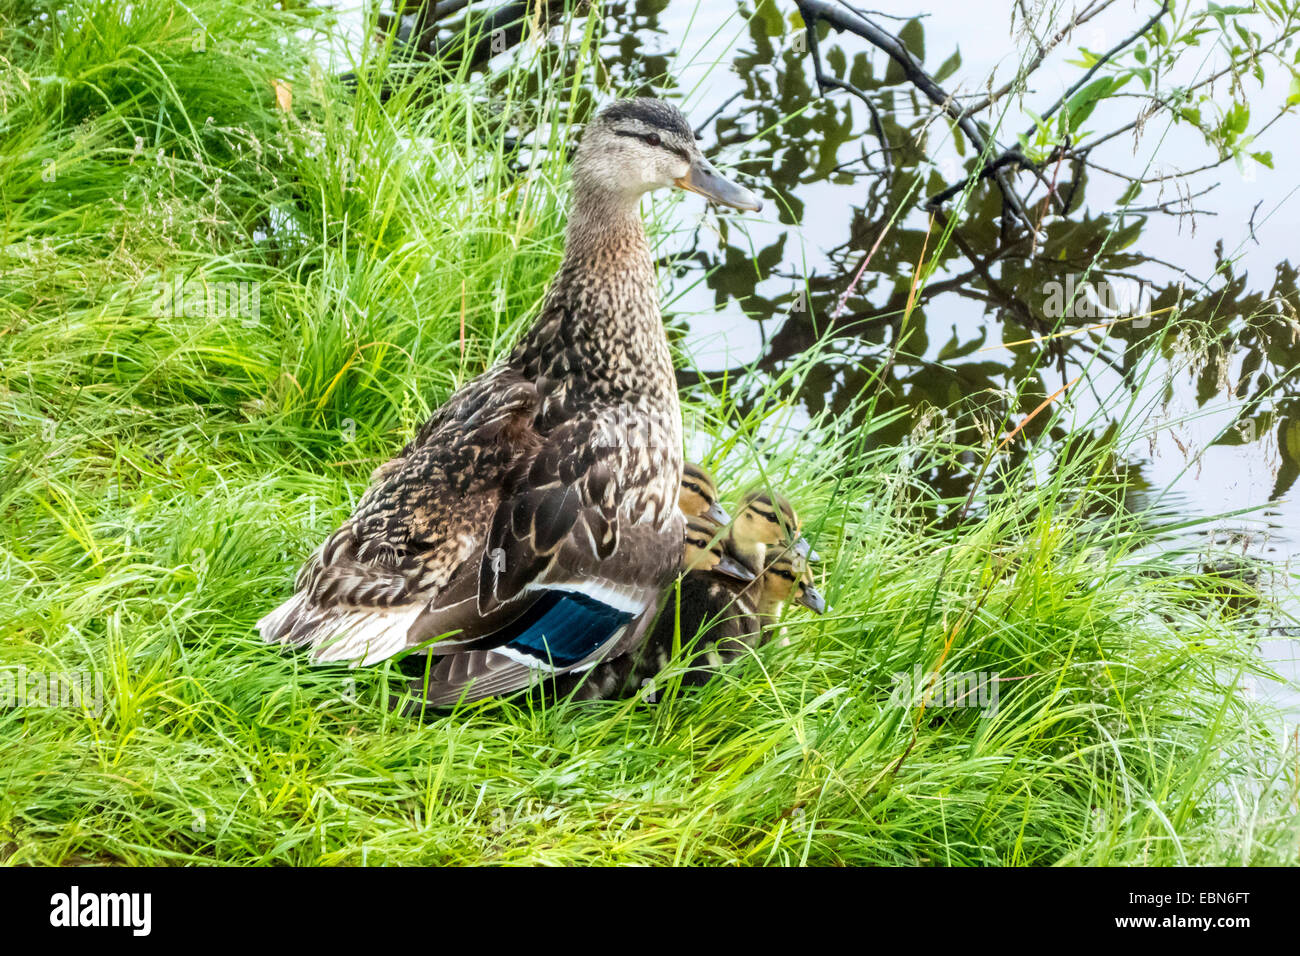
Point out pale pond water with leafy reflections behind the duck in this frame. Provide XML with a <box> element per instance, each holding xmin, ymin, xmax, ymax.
<box><xmin>332</xmin><ymin>0</ymin><xmax>1300</xmax><ymax>710</ymax></box>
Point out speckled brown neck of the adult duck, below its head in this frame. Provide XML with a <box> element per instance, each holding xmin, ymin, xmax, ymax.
<box><xmin>512</xmin><ymin>189</ymin><xmax>676</xmax><ymax>395</ymax></box>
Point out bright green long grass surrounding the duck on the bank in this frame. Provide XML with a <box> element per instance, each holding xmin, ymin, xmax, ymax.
<box><xmin>0</xmin><ymin>0</ymin><xmax>1300</xmax><ymax>865</ymax></box>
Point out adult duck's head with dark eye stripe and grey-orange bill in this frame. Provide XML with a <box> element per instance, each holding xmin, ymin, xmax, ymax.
<box><xmin>573</xmin><ymin>98</ymin><xmax>763</xmax><ymax>212</ymax></box>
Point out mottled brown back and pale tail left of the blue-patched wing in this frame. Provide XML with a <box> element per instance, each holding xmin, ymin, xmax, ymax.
<box><xmin>257</xmin><ymin>367</ymin><xmax>541</xmax><ymax>663</ymax></box>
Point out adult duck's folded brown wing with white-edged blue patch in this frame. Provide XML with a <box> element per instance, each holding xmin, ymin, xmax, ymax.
<box><xmin>390</xmin><ymin>418</ymin><xmax>684</xmax><ymax>705</ymax></box>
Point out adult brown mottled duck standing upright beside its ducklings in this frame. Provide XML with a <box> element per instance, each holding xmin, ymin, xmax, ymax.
<box><xmin>259</xmin><ymin>99</ymin><xmax>761</xmax><ymax>704</ymax></box>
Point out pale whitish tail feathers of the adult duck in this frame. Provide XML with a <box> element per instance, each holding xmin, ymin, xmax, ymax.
<box><xmin>257</xmin><ymin>592</ymin><xmax>424</xmax><ymax>667</ymax></box>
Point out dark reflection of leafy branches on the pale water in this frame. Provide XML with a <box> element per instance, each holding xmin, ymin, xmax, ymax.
<box><xmin>688</xmin><ymin>5</ymin><xmax>1300</xmax><ymax>515</ymax></box>
